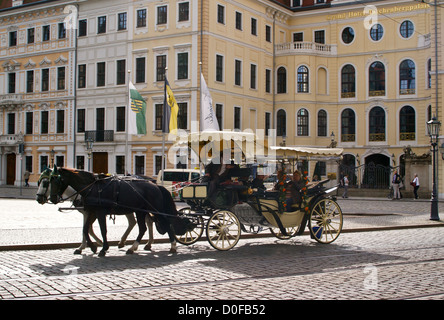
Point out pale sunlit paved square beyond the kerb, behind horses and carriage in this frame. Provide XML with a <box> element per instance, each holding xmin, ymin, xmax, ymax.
<box><xmin>0</xmin><ymin>187</ymin><xmax>444</xmax><ymax>250</ymax></box>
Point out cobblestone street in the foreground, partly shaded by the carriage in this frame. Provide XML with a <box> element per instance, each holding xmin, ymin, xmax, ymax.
<box><xmin>0</xmin><ymin>228</ymin><xmax>444</xmax><ymax>300</ymax></box>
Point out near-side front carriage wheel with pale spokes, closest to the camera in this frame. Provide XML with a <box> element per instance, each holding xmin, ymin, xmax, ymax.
<box><xmin>207</xmin><ymin>210</ymin><xmax>241</xmax><ymax>251</ymax></box>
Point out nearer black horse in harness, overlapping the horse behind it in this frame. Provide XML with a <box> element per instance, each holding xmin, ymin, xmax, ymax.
<box><xmin>50</xmin><ymin>167</ymin><xmax>194</xmax><ymax>256</ymax></box>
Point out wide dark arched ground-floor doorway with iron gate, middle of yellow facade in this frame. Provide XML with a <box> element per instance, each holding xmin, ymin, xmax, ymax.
<box><xmin>362</xmin><ymin>154</ymin><xmax>391</xmax><ymax>189</ymax></box>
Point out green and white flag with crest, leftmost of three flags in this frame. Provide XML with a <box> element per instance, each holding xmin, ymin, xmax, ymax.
<box><xmin>128</xmin><ymin>82</ymin><xmax>146</xmax><ymax>134</ymax></box>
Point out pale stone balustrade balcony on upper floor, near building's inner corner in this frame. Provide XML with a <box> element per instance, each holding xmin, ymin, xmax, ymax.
<box><xmin>276</xmin><ymin>41</ymin><xmax>338</xmax><ymax>56</ymax></box>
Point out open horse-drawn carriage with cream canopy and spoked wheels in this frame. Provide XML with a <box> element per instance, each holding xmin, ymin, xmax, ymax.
<box><xmin>176</xmin><ymin>131</ymin><xmax>343</xmax><ymax>250</ymax></box>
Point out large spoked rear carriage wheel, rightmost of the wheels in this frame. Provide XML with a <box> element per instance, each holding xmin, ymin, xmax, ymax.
<box><xmin>309</xmin><ymin>198</ymin><xmax>342</xmax><ymax>243</ymax></box>
